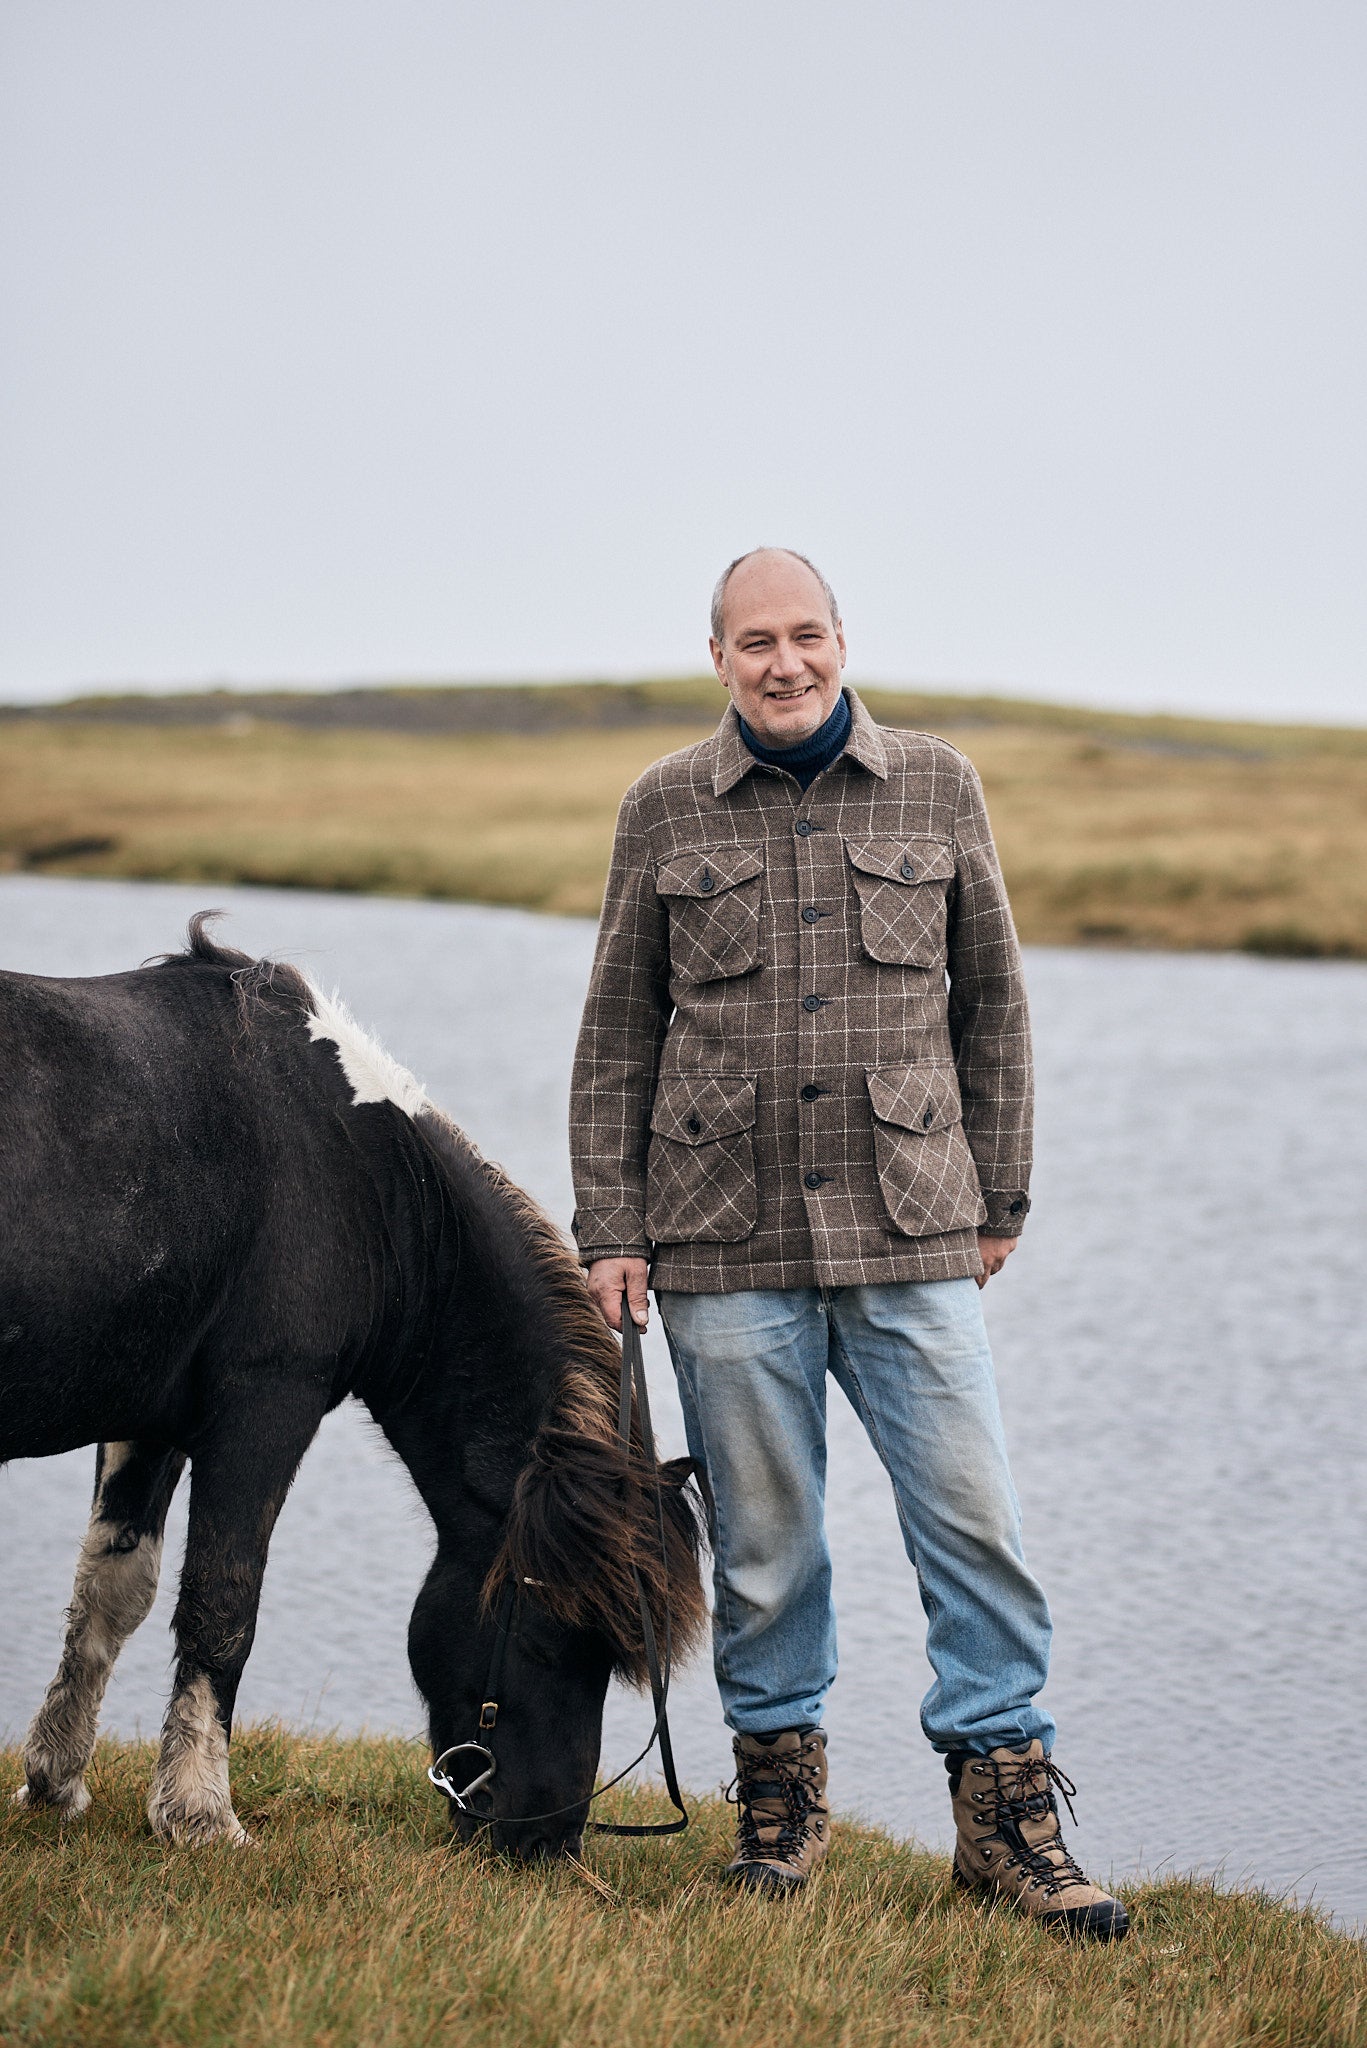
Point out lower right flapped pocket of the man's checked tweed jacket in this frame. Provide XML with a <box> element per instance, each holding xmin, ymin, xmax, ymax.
<box><xmin>867</xmin><ymin>1059</ymin><xmax>988</xmax><ymax>1237</ymax></box>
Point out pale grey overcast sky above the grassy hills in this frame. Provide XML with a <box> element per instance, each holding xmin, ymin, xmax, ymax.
<box><xmin>0</xmin><ymin>0</ymin><xmax>1367</xmax><ymax>723</ymax></box>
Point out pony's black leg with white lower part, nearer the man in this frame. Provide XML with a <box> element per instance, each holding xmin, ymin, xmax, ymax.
<box><xmin>148</xmin><ymin>1397</ymin><xmax>322</xmax><ymax>1845</ymax></box>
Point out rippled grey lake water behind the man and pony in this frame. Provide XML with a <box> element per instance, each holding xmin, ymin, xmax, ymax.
<box><xmin>0</xmin><ymin>877</ymin><xmax>1367</xmax><ymax>1921</ymax></box>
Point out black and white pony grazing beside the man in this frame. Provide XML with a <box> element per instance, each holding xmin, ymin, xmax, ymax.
<box><xmin>0</xmin><ymin>915</ymin><xmax>703</xmax><ymax>1855</ymax></box>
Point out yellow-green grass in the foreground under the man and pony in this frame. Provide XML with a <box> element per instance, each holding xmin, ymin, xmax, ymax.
<box><xmin>0</xmin><ymin>1726</ymin><xmax>1367</xmax><ymax>2048</ymax></box>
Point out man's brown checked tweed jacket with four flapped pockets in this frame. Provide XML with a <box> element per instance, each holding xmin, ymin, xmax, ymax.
<box><xmin>570</xmin><ymin>690</ymin><xmax>1033</xmax><ymax>1294</ymax></box>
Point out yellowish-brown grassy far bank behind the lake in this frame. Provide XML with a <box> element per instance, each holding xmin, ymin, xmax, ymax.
<box><xmin>0</xmin><ymin>682</ymin><xmax>1367</xmax><ymax>958</ymax></box>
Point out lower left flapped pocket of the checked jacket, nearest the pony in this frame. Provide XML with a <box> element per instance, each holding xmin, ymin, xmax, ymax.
<box><xmin>646</xmin><ymin>1073</ymin><xmax>758</xmax><ymax>1245</ymax></box>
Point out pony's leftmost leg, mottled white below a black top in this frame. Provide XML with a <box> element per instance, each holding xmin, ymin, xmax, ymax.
<box><xmin>14</xmin><ymin>1444</ymin><xmax>184</xmax><ymax>1815</ymax></box>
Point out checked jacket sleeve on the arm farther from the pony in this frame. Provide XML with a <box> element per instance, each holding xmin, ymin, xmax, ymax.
<box><xmin>949</xmin><ymin>762</ymin><xmax>1035</xmax><ymax>1237</ymax></box>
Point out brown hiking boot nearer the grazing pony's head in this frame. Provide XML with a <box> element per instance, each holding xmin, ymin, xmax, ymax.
<box><xmin>726</xmin><ymin>1729</ymin><xmax>830</xmax><ymax>1894</ymax></box>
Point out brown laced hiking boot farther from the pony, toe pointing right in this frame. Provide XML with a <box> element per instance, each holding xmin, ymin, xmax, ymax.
<box><xmin>945</xmin><ymin>1741</ymin><xmax>1129</xmax><ymax>1942</ymax></box>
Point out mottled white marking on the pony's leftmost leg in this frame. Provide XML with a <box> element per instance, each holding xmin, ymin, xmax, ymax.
<box><xmin>14</xmin><ymin>1444</ymin><xmax>162</xmax><ymax>1815</ymax></box>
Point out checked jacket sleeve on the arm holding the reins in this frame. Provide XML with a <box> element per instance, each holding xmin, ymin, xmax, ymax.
<box><xmin>570</xmin><ymin>788</ymin><xmax>672</xmax><ymax>1264</ymax></box>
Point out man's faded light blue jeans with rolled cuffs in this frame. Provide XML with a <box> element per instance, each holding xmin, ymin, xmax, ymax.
<box><xmin>658</xmin><ymin>1280</ymin><xmax>1053</xmax><ymax>1753</ymax></box>
